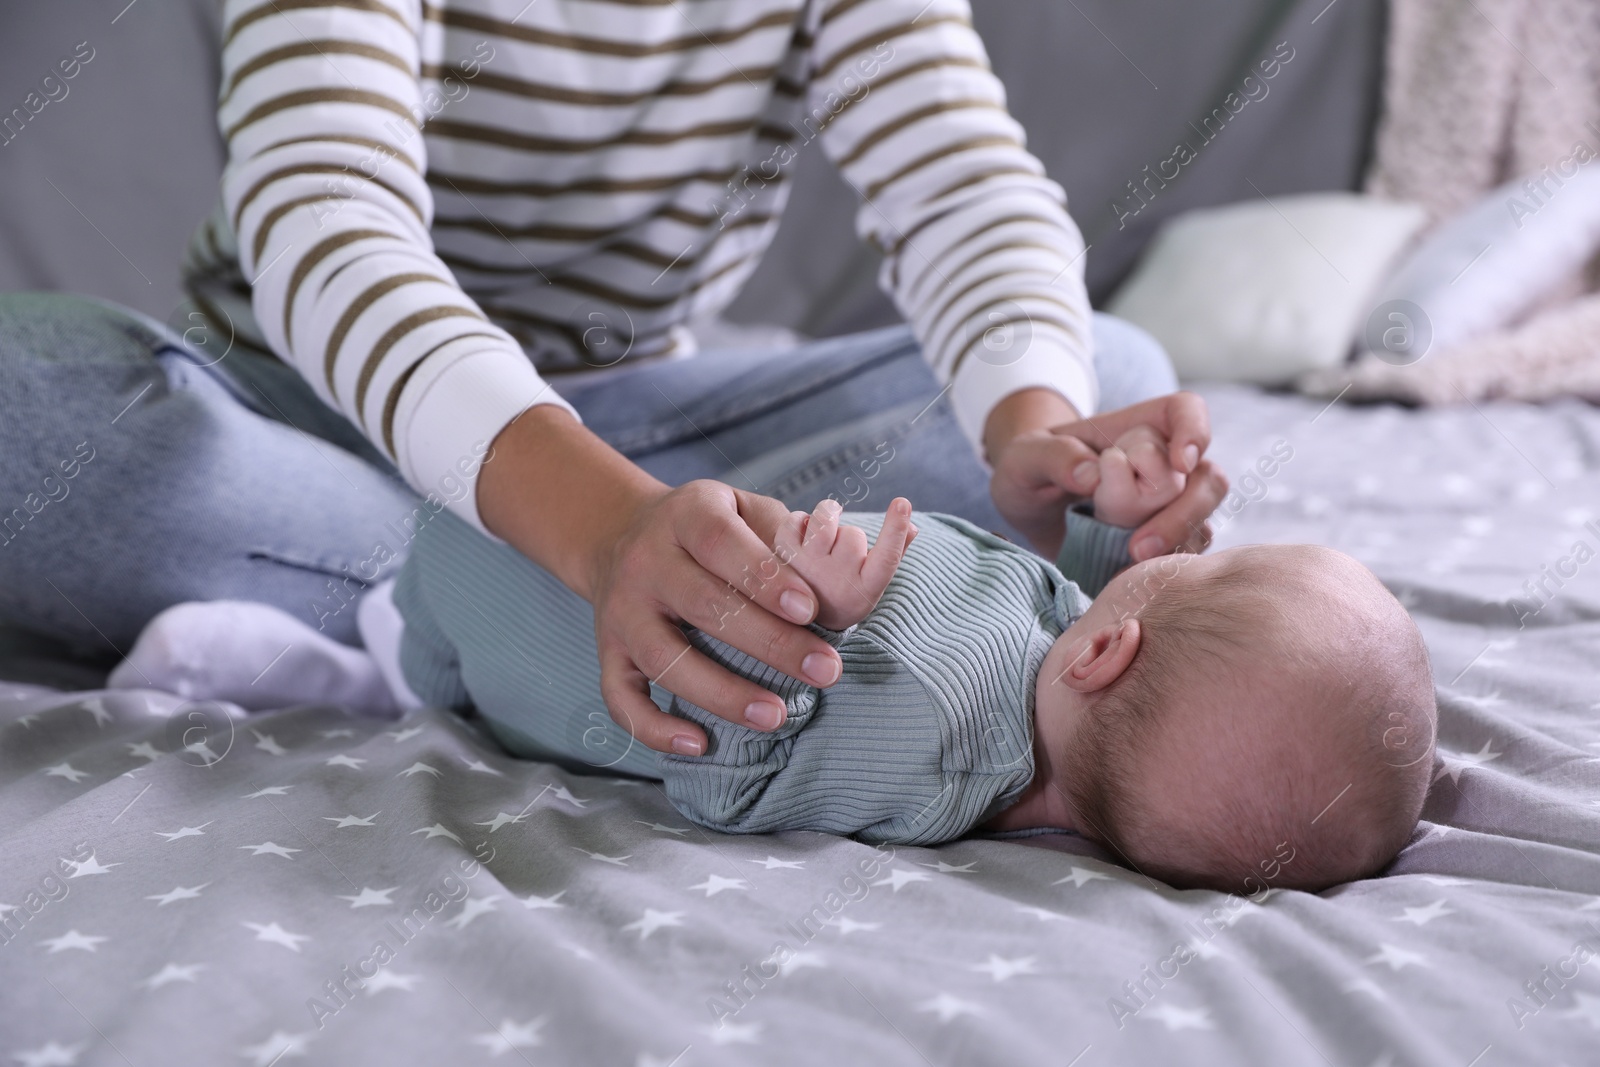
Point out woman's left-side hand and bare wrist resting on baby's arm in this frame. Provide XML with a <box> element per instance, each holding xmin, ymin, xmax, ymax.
<box><xmin>477</xmin><ymin>405</ymin><xmax>840</xmax><ymax>755</ymax></box>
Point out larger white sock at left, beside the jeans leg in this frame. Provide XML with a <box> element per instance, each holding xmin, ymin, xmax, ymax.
<box><xmin>107</xmin><ymin>600</ymin><xmax>400</xmax><ymax>717</ymax></box>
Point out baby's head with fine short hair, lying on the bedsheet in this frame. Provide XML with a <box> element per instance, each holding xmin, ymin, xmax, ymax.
<box><xmin>1067</xmin><ymin>549</ymin><xmax>1437</xmax><ymax>894</ymax></box>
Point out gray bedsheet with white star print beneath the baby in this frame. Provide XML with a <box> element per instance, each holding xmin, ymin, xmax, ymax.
<box><xmin>0</xmin><ymin>389</ymin><xmax>1600</xmax><ymax>1067</ymax></box>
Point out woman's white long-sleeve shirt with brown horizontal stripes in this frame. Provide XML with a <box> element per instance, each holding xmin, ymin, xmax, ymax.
<box><xmin>189</xmin><ymin>0</ymin><xmax>1096</xmax><ymax>523</ymax></box>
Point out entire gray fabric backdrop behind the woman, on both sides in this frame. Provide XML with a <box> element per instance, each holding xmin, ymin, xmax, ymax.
<box><xmin>0</xmin><ymin>0</ymin><xmax>1384</xmax><ymax>336</ymax></box>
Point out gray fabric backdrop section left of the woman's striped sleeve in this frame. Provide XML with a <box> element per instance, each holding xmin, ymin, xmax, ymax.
<box><xmin>0</xmin><ymin>0</ymin><xmax>224</xmax><ymax>326</ymax></box>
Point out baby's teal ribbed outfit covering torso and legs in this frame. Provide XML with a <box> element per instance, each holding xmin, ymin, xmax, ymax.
<box><xmin>395</xmin><ymin>514</ymin><xmax>1088</xmax><ymax>845</ymax></box>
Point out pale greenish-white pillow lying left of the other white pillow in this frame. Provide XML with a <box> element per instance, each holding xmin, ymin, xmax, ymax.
<box><xmin>1106</xmin><ymin>192</ymin><xmax>1427</xmax><ymax>386</ymax></box>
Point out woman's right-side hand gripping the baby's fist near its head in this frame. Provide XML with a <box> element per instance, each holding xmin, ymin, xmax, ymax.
<box><xmin>984</xmin><ymin>389</ymin><xmax>1227</xmax><ymax>561</ymax></box>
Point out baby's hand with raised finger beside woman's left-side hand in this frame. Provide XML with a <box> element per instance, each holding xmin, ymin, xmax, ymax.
<box><xmin>773</xmin><ymin>496</ymin><xmax>917</xmax><ymax>630</ymax></box>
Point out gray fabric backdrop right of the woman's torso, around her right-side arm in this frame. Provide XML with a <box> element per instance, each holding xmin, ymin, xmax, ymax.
<box><xmin>728</xmin><ymin>0</ymin><xmax>1387</xmax><ymax>336</ymax></box>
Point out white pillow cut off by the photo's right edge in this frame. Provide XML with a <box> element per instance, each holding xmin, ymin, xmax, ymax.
<box><xmin>1362</xmin><ymin>157</ymin><xmax>1600</xmax><ymax>355</ymax></box>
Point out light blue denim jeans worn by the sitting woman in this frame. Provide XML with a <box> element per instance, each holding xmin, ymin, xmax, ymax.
<box><xmin>0</xmin><ymin>294</ymin><xmax>1178</xmax><ymax>653</ymax></box>
